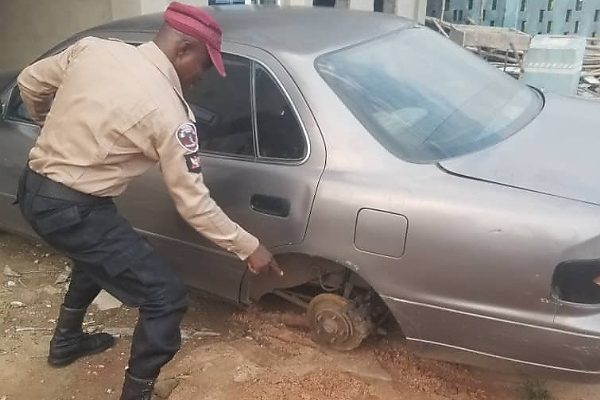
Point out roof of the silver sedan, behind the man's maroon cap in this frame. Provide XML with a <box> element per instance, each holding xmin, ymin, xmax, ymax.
<box><xmin>88</xmin><ymin>5</ymin><xmax>416</xmax><ymax>55</ymax></box>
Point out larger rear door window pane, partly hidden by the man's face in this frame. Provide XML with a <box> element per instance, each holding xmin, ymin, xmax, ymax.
<box><xmin>187</xmin><ymin>55</ymin><xmax>255</xmax><ymax>157</ymax></box>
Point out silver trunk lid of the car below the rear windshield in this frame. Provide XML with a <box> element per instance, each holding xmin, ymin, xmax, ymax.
<box><xmin>441</xmin><ymin>94</ymin><xmax>600</xmax><ymax>204</ymax></box>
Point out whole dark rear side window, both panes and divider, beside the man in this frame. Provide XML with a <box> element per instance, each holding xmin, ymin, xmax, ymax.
<box><xmin>187</xmin><ymin>54</ymin><xmax>308</xmax><ymax>161</ymax></box>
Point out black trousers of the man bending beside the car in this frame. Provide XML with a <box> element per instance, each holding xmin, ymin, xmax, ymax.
<box><xmin>17</xmin><ymin>168</ymin><xmax>188</xmax><ymax>379</ymax></box>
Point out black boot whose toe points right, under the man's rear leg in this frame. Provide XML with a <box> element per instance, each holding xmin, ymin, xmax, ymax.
<box><xmin>48</xmin><ymin>305</ymin><xmax>115</xmax><ymax>367</ymax></box>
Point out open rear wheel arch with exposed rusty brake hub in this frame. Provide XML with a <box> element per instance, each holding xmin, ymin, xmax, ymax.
<box><xmin>240</xmin><ymin>253</ymin><xmax>403</xmax><ymax>350</ymax></box>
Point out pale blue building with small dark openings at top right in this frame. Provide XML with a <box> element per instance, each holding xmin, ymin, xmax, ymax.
<box><xmin>427</xmin><ymin>0</ymin><xmax>600</xmax><ymax>37</ymax></box>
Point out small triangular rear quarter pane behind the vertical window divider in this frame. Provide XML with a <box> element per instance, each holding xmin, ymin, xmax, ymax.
<box><xmin>254</xmin><ymin>65</ymin><xmax>306</xmax><ymax>160</ymax></box>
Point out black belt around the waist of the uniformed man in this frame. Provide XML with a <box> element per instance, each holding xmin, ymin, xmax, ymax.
<box><xmin>25</xmin><ymin>166</ymin><xmax>112</xmax><ymax>204</ymax></box>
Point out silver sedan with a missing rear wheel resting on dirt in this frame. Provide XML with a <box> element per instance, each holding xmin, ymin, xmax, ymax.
<box><xmin>0</xmin><ymin>7</ymin><xmax>600</xmax><ymax>374</ymax></box>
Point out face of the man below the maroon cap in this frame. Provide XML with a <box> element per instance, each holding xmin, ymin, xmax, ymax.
<box><xmin>174</xmin><ymin>41</ymin><xmax>212</xmax><ymax>91</ymax></box>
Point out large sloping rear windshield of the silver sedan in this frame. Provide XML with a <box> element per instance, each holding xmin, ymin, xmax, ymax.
<box><xmin>315</xmin><ymin>27</ymin><xmax>543</xmax><ymax>163</ymax></box>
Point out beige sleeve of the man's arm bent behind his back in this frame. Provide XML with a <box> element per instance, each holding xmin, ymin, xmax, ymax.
<box><xmin>17</xmin><ymin>39</ymin><xmax>88</xmax><ymax>125</ymax></box>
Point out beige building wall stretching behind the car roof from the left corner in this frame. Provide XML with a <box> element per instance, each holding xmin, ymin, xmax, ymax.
<box><xmin>0</xmin><ymin>0</ymin><xmax>427</xmax><ymax>72</ymax></box>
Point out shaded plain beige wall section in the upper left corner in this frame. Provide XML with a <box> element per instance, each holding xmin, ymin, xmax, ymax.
<box><xmin>0</xmin><ymin>0</ymin><xmax>112</xmax><ymax>71</ymax></box>
